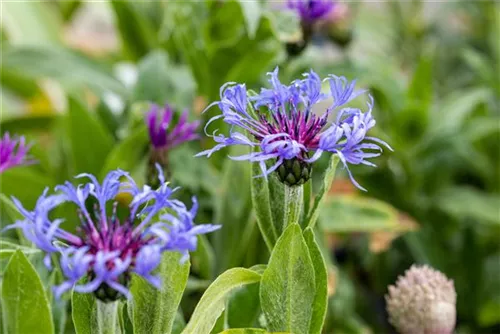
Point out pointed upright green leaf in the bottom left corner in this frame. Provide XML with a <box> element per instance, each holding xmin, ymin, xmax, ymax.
<box><xmin>2</xmin><ymin>250</ymin><xmax>54</xmax><ymax>334</ymax></box>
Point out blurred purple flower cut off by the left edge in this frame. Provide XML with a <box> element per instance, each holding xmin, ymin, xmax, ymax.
<box><xmin>0</xmin><ymin>132</ymin><xmax>33</xmax><ymax>173</ymax></box>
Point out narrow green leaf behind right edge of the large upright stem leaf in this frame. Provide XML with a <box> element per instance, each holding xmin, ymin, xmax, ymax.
<box><xmin>304</xmin><ymin>227</ymin><xmax>328</xmax><ymax>334</ymax></box>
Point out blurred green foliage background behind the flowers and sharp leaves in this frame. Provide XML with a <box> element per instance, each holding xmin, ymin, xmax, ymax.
<box><xmin>0</xmin><ymin>0</ymin><xmax>500</xmax><ymax>334</ymax></box>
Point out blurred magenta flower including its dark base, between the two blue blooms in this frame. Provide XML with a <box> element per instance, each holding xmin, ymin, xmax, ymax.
<box><xmin>145</xmin><ymin>104</ymin><xmax>200</xmax><ymax>185</ymax></box>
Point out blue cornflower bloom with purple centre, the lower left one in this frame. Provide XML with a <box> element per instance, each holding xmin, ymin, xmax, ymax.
<box><xmin>3</xmin><ymin>168</ymin><xmax>219</xmax><ymax>301</ymax></box>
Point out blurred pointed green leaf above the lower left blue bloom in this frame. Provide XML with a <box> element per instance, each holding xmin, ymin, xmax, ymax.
<box><xmin>67</xmin><ymin>98</ymin><xmax>113</xmax><ymax>175</ymax></box>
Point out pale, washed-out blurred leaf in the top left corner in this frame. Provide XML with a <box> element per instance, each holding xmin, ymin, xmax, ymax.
<box><xmin>2</xmin><ymin>1</ymin><xmax>62</xmax><ymax>45</ymax></box>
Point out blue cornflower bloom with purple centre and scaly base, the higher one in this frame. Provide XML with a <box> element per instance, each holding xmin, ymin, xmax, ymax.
<box><xmin>197</xmin><ymin>68</ymin><xmax>391</xmax><ymax>190</ymax></box>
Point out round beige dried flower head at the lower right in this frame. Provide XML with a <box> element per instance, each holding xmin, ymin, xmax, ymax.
<box><xmin>386</xmin><ymin>266</ymin><xmax>457</xmax><ymax>334</ymax></box>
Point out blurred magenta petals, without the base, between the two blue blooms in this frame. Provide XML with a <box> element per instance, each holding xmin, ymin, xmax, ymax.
<box><xmin>146</xmin><ymin>104</ymin><xmax>199</xmax><ymax>149</ymax></box>
